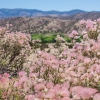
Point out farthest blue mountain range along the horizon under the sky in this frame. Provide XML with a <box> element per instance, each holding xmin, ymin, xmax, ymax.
<box><xmin>0</xmin><ymin>8</ymin><xmax>86</xmax><ymax>18</ymax></box>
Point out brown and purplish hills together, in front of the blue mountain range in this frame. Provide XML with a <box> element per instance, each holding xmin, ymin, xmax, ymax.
<box><xmin>0</xmin><ymin>11</ymin><xmax>100</xmax><ymax>33</ymax></box>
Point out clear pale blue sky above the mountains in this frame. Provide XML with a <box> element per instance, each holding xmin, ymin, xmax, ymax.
<box><xmin>0</xmin><ymin>0</ymin><xmax>100</xmax><ymax>11</ymax></box>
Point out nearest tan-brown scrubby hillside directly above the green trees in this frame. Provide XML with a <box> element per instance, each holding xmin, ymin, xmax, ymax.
<box><xmin>0</xmin><ymin>17</ymin><xmax>77</xmax><ymax>33</ymax></box>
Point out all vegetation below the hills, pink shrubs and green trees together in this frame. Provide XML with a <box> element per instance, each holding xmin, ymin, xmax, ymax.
<box><xmin>0</xmin><ymin>19</ymin><xmax>100</xmax><ymax>100</ymax></box>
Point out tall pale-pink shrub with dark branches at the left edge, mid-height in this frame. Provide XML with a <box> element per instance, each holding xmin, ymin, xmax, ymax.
<box><xmin>0</xmin><ymin>28</ymin><xmax>31</xmax><ymax>73</ymax></box>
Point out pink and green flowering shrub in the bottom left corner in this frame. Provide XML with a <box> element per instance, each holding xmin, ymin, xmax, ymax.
<box><xmin>0</xmin><ymin>73</ymin><xmax>24</xmax><ymax>100</ymax></box>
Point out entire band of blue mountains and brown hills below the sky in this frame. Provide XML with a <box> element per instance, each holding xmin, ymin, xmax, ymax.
<box><xmin>0</xmin><ymin>9</ymin><xmax>100</xmax><ymax>33</ymax></box>
